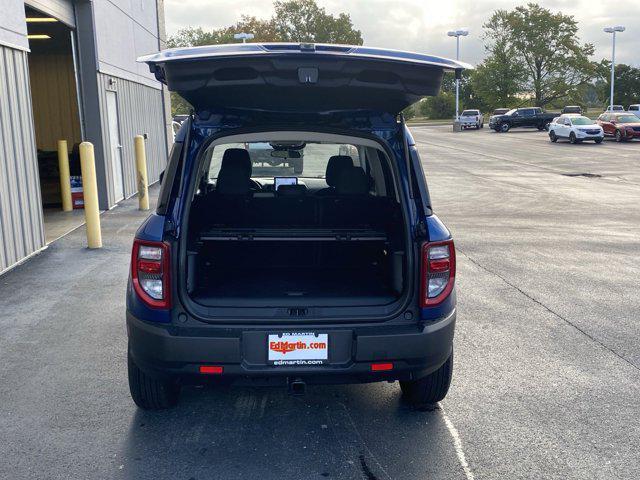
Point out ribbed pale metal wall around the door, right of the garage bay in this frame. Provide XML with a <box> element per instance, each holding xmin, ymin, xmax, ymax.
<box><xmin>98</xmin><ymin>73</ymin><xmax>167</xmax><ymax>205</ymax></box>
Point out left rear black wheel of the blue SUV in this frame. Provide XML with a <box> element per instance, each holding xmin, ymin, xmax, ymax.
<box><xmin>127</xmin><ymin>346</ymin><xmax>180</xmax><ymax>410</ymax></box>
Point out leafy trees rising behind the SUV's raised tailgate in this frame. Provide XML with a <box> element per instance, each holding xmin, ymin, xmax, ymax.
<box><xmin>167</xmin><ymin>0</ymin><xmax>363</xmax><ymax>115</ymax></box>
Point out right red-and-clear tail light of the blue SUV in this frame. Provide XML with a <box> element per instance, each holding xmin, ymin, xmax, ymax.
<box><xmin>420</xmin><ymin>240</ymin><xmax>456</xmax><ymax>307</ymax></box>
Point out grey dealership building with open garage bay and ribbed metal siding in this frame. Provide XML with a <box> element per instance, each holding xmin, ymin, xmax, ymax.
<box><xmin>0</xmin><ymin>0</ymin><xmax>171</xmax><ymax>273</ymax></box>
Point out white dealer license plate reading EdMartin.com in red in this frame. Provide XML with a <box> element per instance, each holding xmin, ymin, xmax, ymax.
<box><xmin>267</xmin><ymin>333</ymin><xmax>329</xmax><ymax>366</ymax></box>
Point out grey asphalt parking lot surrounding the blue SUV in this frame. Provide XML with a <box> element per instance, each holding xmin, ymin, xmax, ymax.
<box><xmin>0</xmin><ymin>127</ymin><xmax>640</xmax><ymax>480</ymax></box>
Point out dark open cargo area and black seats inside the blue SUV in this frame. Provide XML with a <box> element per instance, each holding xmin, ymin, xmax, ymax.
<box><xmin>186</xmin><ymin>133</ymin><xmax>406</xmax><ymax>308</ymax></box>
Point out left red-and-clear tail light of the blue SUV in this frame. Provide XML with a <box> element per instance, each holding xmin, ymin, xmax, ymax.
<box><xmin>131</xmin><ymin>240</ymin><xmax>171</xmax><ymax>308</ymax></box>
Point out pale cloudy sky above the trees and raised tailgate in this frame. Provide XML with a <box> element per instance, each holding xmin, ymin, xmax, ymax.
<box><xmin>165</xmin><ymin>0</ymin><xmax>640</xmax><ymax>67</ymax></box>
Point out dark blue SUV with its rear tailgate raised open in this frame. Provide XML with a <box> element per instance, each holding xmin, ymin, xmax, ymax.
<box><xmin>127</xmin><ymin>44</ymin><xmax>467</xmax><ymax>409</ymax></box>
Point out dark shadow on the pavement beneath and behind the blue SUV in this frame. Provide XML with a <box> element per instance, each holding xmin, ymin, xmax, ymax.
<box><xmin>121</xmin><ymin>383</ymin><xmax>462</xmax><ymax>480</ymax></box>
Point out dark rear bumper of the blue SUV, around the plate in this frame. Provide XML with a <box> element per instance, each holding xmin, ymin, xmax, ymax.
<box><xmin>127</xmin><ymin>310</ymin><xmax>456</xmax><ymax>384</ymax></box>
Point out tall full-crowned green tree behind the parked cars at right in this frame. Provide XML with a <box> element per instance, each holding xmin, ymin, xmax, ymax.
<box><xmin>484</xmin><ymin>3</ymin><xmax>594</xmax><ymax>107</ymax></box>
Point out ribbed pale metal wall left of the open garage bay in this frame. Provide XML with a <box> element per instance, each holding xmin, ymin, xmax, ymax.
<box><xmin>0</xmin><ymin>45</ymin><xmax>45</xmax><ymax>273</ymax></box>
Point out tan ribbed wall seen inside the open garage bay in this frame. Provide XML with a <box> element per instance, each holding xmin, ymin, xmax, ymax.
<box><xmin>29</xmin><ymin>53</ymin><xmax>82</xmax><ymax>150</ymax></box>
